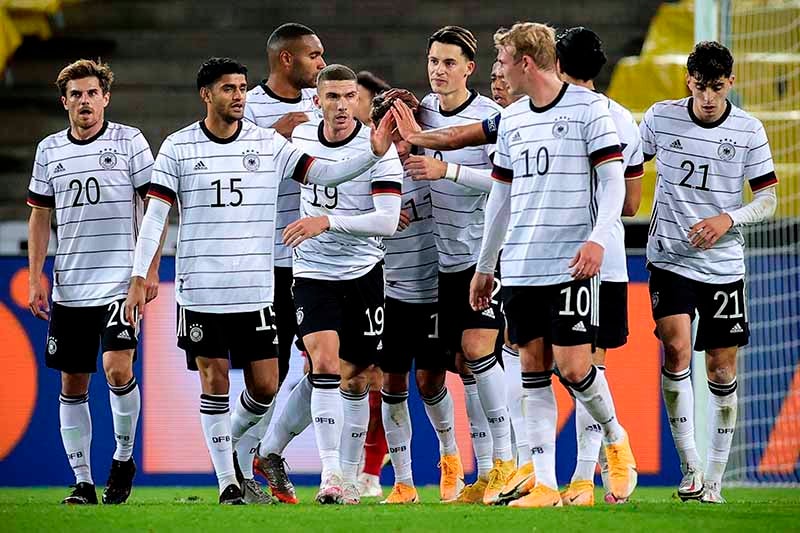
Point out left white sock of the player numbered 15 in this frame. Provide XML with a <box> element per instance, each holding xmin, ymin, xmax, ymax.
<box><xmin>200</xmin><ymin>394</ymin><xmax>238</xmax><ymax>494</ymax></box>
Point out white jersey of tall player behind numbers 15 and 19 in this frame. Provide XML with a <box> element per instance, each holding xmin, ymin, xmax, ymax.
<box><xmin>244</xmin><ymin>81</ymin><xmax>318</xmax><ymax>267</ymax></box>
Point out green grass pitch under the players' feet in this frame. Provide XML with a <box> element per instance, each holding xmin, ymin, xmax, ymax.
<box><xmin>0</xmin><ymin>487</ymin><xmax>800</xmax><ymax>533</ymax></box>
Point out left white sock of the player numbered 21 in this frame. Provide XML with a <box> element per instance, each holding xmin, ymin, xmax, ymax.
<box><xmin>661</xmin><ymin>367</ymin><xmax>700</xmax><ymax>472</ymax></box>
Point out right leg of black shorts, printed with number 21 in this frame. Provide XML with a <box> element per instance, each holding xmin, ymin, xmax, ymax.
<box><xmin>694</xmin><ymin>279</ymin><xmax>750</xmax><ymax>351</ymax></box>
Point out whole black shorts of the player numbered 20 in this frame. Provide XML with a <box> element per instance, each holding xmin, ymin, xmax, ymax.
<box><xmin>45</xmin><ymin>299</ymin><xmax>139</xmax><ymax>374</ymax></box>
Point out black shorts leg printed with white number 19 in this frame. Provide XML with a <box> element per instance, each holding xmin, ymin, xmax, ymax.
<box><xmin>339</xmin><ymin>263</ymin><xmax>386</xmax><ymax>368</ymax></box>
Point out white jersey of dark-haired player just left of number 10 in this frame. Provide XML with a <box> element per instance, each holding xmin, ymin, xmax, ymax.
<box><xmin>417</xmin><ymin>91</ymin><xmax>501</xmax><ymax>272</ymax></box>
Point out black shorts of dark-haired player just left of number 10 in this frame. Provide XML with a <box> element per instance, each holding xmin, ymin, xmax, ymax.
<box><xmin>439</xmin><ymin>265</ymin><xmax>505</xmax><ymax>354</ymax></box>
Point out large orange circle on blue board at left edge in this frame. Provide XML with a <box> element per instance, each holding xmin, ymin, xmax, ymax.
<box><xmin>0</xmin><ymin>302</ymin><xmax>37</xmax><ymax>461</ymax></box>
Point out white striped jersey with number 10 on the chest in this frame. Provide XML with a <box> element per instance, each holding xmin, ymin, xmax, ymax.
<box><xmin>492</xmin><ymin>83</ymin><xmax>622</xmax><ymax>285</ymax></box>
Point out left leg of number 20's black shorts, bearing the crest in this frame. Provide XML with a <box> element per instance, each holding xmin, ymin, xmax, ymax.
<box><xmin>45</xmin><ymin>303</ymin><xmax>105</xmax><ymax>374</ymax></box>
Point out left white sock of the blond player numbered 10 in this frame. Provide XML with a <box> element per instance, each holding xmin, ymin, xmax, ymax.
<box><xmin>522</xmin><ymin>370</ymin><xmax>558</xmax><ymax>490</ymax></box>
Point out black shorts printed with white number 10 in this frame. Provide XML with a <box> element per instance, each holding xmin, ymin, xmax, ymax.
<box><xmin>504</xmin><ymin>276</ymin><xmax>600</xmax><ymax>346</ymax></box>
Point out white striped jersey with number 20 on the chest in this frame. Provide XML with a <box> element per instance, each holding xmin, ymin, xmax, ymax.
<box><xmin>28</xmin><ymin>122</ymin><xmax>153</xmax><ymax>307</ymax></box>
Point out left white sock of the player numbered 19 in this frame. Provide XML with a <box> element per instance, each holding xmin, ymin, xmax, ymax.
<box><xmin>311</xmin><ymin>374</ymin><xmax>342</xmax><ymax>480</ymax></box>
